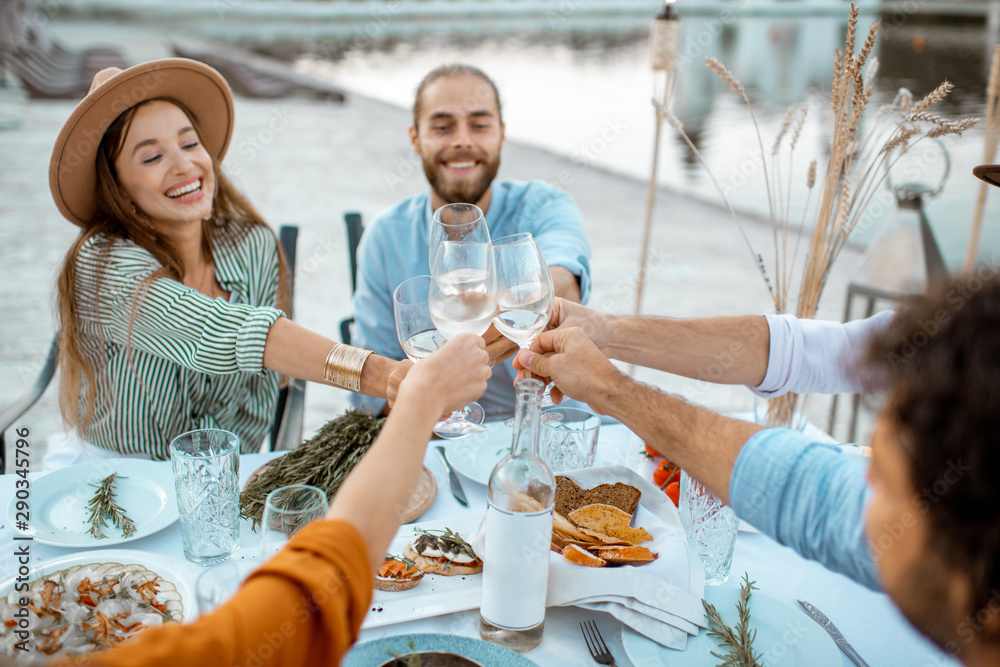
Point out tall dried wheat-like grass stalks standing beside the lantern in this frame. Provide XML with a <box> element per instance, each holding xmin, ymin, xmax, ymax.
<box><xmin>670</xmin><ymin>4</ymin><xmax>976</xmax><ymax>424</ymax></box>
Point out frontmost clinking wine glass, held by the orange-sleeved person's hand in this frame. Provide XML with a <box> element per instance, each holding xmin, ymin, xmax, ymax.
<box><xmin>428</xmin><ymin>241</ymin><xmax>497</xmax><ymax>438</ymax></box>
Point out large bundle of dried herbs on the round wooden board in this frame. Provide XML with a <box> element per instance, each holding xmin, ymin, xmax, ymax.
<box><xmin>240</xmin><ymin>410</ymin><xmax>385</xmax><ymax>531</ymax></box>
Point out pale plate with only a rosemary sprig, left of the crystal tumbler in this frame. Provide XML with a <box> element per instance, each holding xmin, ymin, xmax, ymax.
<box><xmin>7</xmin><ymin>459</ymin><xmax>177</xmax><ymax>548</ymax></box>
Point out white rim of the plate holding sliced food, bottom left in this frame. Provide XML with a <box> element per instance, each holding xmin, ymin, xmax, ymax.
<box><xmin>0</xmin><ymin>549</ymin><xmax>202</xmax><ymax>621</ymax></box>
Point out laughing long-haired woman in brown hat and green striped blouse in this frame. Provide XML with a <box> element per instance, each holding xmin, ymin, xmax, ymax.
<box><xmin>46</xmin><ymin>58</ymin><xmax>405</xmax><ymax>467</ymax></box>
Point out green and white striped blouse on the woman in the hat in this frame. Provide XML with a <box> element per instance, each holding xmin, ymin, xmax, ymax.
<box><xmin>76</xmin><ymin>222</ymin><xmax>282</xmax><ymax>459</ymax></box>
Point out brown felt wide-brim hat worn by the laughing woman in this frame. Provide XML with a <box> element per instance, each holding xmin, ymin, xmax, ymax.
<box><xmin>49</xmin><ymin>58</ymin><xmax>234</xmax><ymax>227</ymax></box>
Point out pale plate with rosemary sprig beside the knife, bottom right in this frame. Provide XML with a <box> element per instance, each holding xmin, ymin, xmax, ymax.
<box><xmin>622</xmin><ymin>586</ymin><xmax>843</xmax><ymax>667</ymax></box>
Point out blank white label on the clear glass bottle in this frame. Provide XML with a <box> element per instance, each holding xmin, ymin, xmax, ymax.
<box><xmin>480</xmin><ymin>505</ymin><xmax>552</xmax><ymax>630</ymax></box>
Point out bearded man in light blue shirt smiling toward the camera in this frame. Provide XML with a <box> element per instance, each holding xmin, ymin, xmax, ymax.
<box><xmin>351</xmin><ymin>65</ymin><xmax>590</xmax><ymax>420</ymax></box>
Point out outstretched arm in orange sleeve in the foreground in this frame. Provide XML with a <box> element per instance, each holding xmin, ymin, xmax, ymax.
<box><xmin>51</xmin><ymin>334</ymin><xmax>490</xmax><ymax>667</ymax></box>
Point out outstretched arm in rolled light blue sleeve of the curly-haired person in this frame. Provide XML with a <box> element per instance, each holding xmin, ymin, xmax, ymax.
<box><xmin>518</xmin><ymin>328</ymin><xmax>878</xmax><ymax>589</ymax></box>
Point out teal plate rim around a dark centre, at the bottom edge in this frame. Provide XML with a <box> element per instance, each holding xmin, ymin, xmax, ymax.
<box><xmin>341</xmin><ymin>634</ymin><xmax>535</xmax><ymax>667</ymax></box>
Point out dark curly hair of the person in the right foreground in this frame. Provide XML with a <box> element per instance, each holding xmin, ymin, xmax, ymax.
<box><xmin>869</xmin><ymin>267</ymin><xmax>1000</xmax><ymax>624</ymax></box>
